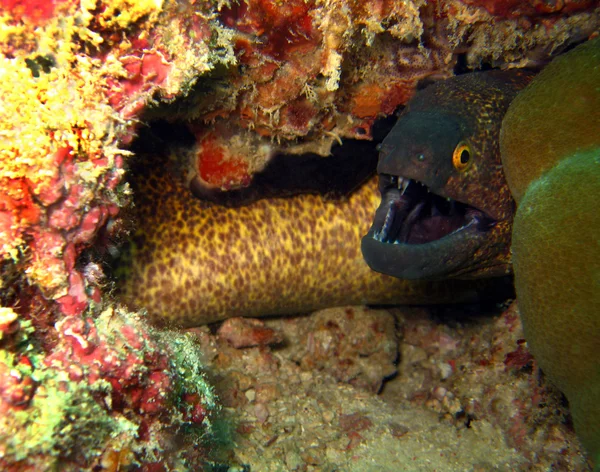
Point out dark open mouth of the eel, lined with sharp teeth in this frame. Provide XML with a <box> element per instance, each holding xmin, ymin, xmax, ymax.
<box><xmin>372</xmin><ymin>174</ymin><xmax>495</xmax><ymax>244</ymax></box>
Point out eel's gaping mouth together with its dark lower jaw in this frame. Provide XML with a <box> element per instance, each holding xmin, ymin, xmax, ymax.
<box><xmin>361</xmin><ymin>174</ymin><xmax>496</xmax><ymax>279</ymax></box>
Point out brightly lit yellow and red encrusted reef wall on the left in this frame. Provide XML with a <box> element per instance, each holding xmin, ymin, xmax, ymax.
<box><xmin>0</xmin><ymin>1</ymin><xmax>233</xmax><ymax>470</ymax></box>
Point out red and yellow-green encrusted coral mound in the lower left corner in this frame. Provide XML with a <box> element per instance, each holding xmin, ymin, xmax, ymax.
<box><xmin>0</xmin><ymin>308</ymin><xmax>217</xmax><ymax>470</ymax></box>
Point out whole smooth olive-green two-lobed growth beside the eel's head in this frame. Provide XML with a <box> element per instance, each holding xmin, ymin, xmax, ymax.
<box><xmin>500</xmin><ymin>39</ymin><xmax>600</xmax><ymax>470</ymax></box>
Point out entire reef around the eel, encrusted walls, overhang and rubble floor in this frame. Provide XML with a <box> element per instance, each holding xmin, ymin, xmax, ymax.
<box><xmin>0</xmin><ymin>0</ymin><xmax>600</xmax><ymax>471</ymax></box>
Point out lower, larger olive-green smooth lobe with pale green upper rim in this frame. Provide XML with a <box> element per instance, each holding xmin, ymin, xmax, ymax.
<box><xmin>512</xmin><ymin>147</ymin><xmax>600</xmax><ymax>470</ymax></box>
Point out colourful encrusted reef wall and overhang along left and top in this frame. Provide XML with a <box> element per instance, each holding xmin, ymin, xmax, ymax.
<box><xmin>0</xmin><ymin>0</ymin><xmax>599</xmax><ymax>470</ymax></box>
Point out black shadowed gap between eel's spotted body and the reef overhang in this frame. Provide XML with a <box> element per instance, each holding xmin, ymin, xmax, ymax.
<box><xmin>129</xmin><ymin>112</ymin><xmax>396</xmax><ymax>207</ymax></box>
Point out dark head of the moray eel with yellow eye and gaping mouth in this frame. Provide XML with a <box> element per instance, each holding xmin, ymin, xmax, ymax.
<box><xmin>362</xmin><ymin>71</ymin><xmax>533</xmax><ymax>279</ymax></box>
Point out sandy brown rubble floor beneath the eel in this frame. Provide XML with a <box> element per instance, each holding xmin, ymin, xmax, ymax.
<box><xmin>194</xmin><ymin>305</ymin><xmax>590</xmax><ymax>472</ymax></box>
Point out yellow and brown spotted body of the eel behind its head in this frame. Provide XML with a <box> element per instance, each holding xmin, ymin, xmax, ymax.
<box><xmin>121</xmin><ymin>156</ymin><xmax>488</xmax><ymax>326</ymax></box>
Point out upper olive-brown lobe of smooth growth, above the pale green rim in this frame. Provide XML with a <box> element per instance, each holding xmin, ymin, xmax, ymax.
<box><xmin>500</xmin><ymin>37</ymin><xmax>600</xmax><ymax>202</ymax></box>
